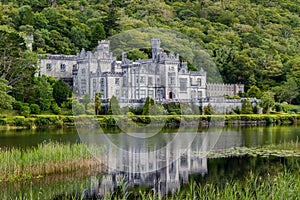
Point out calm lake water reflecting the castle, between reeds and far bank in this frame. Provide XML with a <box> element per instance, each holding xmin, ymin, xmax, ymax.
<box><xmin>0</xmin><ymin>126</ymin><xmax>300</xmax><ymax>199</ymax></box>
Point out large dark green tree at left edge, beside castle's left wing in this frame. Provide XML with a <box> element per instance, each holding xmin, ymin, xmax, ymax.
<box><xmin>0</xmin><ymin>30</ymin><xmax>37</xmax><ymax>91</ymax></box>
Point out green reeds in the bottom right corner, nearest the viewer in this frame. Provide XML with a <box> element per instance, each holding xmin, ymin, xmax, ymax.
<box><xmin>108</xmin><ymin>169</ymin><xmax>300</xmax><ymax>200</ymax></box>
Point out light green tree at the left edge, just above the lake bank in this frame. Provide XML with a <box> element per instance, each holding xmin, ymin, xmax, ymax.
<box><xmin>0</xmin><ymin>78</ymin><xmax>14</xmax><ymax>110</ymax></box>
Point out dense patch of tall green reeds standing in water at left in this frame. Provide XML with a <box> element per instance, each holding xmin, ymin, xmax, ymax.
<box><xmin>0</xmin><ymin>143</ymin><xmax>101</xmax><ymax>182</ymax></box>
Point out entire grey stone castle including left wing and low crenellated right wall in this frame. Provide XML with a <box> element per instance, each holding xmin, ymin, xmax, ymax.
<box><xmin>40</xmin><ymin>38</ymin><xmax>244</xmax><ymax>102</ymax></box>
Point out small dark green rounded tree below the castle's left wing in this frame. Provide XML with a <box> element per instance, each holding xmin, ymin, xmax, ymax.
<box><xmin>53</xmin><ymin>79</ymin><xmax>70</xmax><ymax>106</ymax></box>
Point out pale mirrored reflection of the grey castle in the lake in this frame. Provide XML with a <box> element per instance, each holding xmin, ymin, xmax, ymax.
<box><xmin>89</xmin><ymin>132</ymin><xmax>242</xmax><ymax>196</ymax></box>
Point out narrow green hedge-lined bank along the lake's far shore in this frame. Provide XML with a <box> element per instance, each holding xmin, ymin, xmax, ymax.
<box><xmin>0</xmin><ymin>113</ymin><xmax>300</xmax><ymax>129</ymax></box>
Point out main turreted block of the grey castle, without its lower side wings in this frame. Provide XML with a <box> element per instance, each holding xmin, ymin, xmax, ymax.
<box><xmin>74</xmin><ymin>39</ymin><xmax>206</xmax><ymax>100</ymax></box>
